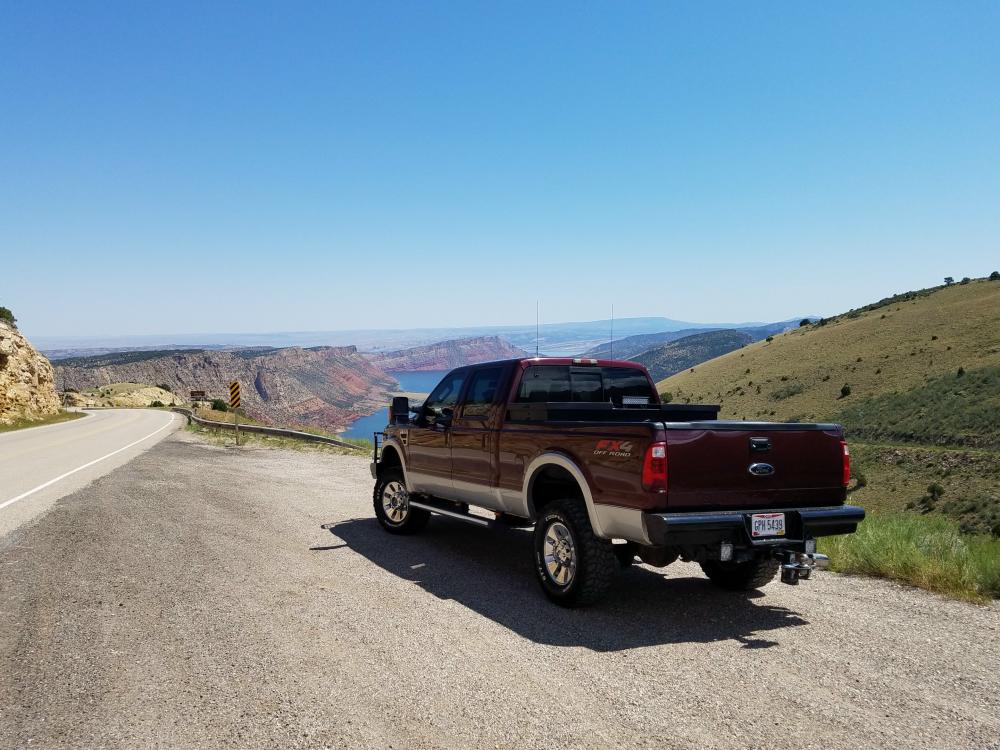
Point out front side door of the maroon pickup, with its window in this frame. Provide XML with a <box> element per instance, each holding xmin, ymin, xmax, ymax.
<box><xmin>406</xmin><ymin>369</ymin><xmax>468</xmax><ymax>499</ymax></box>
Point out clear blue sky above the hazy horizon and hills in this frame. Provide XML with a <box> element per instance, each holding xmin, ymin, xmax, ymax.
<box><xmin>0</xmin><ymin>2</ymin><xmax>1000</xmax><ymax>335</ymax></box>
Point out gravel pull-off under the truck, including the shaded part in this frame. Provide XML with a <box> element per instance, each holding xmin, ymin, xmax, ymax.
<box><xmin>0</xmin><ymin>432</ymin><xmax>1000</xmax><ymax>750</ymax></box>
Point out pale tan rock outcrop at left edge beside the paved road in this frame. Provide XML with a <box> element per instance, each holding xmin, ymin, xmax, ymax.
<box><xmin>0</xmin><ymin>321</ymin><xmax>59</xmax><ymax>424</ymax></box>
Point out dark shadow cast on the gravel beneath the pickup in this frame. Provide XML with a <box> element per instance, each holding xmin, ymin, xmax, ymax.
<box><xmin>320</xmin><ymin>518</ymin><xmax>808</xmax><ymax>651</ymax></box>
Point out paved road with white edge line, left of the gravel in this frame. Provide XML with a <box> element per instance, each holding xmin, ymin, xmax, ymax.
<box><xmin>0</xmin><ymin>409</ymin><xmax>183</xmax><ymax>535</ymax></box>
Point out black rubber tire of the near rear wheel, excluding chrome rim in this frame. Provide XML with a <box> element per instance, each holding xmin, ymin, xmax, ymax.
<box><xmin>533</xmin><ymin>499</ymin><xmax>620</xmax><ymax>607</ymax></box>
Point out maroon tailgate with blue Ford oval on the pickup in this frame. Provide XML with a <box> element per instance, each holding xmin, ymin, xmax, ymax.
<box><xmin>666</xmin><ymin>422</ymin><xmax>846</xmax><ymax>511</ymax></box>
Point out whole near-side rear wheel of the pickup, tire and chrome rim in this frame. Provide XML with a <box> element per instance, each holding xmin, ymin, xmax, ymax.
<box><xmin>534</xmin><ymin>500</ymin><xmax>619</xmax><ymax>607</ymax></box>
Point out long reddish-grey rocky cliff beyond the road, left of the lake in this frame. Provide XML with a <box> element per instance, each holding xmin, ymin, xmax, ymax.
<box><xmin>56</xmin><ymin>346</ymin><xmax>397</xmax><ymax>430</ymax></box>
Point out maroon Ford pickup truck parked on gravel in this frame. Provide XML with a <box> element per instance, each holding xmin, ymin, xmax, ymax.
<box><xmin>372</xmin><ymin>358</ymin><xmax>865</xmax><ymax>606</ymax></box>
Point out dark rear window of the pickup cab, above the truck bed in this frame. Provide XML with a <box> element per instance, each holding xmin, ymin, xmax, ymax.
<box><xmin>515</xmin><ymin>365</ymin><xmax>656</xmax><ymax>406</ymax></box>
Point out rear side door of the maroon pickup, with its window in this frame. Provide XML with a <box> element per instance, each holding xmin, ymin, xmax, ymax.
<box><xmin>451</xmin><ymin>365</ymin><xmax>510</xmax><ymax>510</ymax></box>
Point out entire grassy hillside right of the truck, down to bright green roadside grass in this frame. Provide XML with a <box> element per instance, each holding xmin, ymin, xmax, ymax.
<box><xmin>658</xmin><ymin>279</ymin><xmax>1000</xmax><ymax>599</ymax></box>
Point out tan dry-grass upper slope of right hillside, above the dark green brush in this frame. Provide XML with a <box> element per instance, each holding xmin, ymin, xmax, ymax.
<box><xmin>659</xmin><ymin>280</ymin><xmax>1000</xmax><ymax>429</ymax></box>
